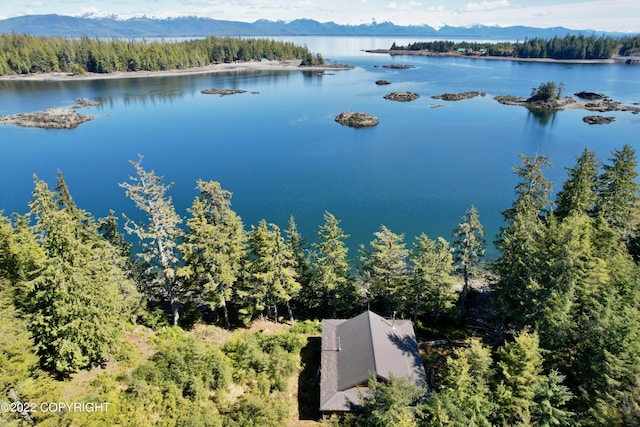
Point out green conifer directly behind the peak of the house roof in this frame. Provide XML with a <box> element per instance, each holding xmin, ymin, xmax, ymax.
<box><xmin>361</xmin><ymin>225</ymin><xmax>409</xmax><ymax>315</ymax></box>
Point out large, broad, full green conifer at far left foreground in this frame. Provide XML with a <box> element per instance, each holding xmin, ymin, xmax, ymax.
<box><xmin>25</xmin><ymin>177</ymin><xmax>136</xmax><ymax>375</ymax></box>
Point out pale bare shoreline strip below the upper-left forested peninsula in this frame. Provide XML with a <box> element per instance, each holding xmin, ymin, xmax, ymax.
<box><xmin>0</xmin><ymin>60</ymin><xmax>352</xmax><ymax>81</ymax></box>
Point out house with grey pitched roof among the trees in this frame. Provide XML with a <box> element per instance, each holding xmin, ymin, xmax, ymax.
<box><xmin>320</xmin><ymin>311</ymin><xmax>427</xmax><ymax>415</ymax></box>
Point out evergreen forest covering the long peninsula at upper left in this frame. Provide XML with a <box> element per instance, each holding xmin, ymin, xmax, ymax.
<box><xmin>0</xmin><ymin>33</ymin><xmax>324</xmax><ymax>75</ymax></box>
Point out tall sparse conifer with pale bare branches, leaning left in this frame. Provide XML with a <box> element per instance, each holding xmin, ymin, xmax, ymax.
<box><xmin>120</xmin><ymin>156</ymin><xmax>186</xmax><ymax>326</ymax></box>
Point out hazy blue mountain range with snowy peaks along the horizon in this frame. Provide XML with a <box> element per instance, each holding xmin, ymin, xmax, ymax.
<box><xmin>0</xmin><ymin>15</ymin><xmax>627</xmax><ymax>40</ymax></box>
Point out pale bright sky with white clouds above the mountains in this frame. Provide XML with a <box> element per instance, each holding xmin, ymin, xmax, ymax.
<box><xmin>0</xmin><ymin>0</ymin><xmax>640</xmax><ymax>33</ymax></box>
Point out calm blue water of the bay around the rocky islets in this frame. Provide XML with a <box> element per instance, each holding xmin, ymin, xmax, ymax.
<box><xmin>0</xmin><ymin>37</ymin><xmax>640</xmax><ymax>258</ymax></box>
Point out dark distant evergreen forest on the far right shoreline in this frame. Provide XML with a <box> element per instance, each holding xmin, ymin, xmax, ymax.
<box><xmin>391</xmin><ymin>35</ymin><xmax>640</xmax><ymax>59</ymax></box>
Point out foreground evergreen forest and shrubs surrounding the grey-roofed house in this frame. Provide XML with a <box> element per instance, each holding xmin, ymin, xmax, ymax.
<box><xmin>0</xmin><ymin>145</ymin><xmax>640</xmax><ymax>426</ymax></box>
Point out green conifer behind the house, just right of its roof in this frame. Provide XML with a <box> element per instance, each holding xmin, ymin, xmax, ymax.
<box><xmin>409</xmin><ymin>233</ymin><xmax>455</xmax><ymax>322</ymax></box>
